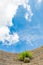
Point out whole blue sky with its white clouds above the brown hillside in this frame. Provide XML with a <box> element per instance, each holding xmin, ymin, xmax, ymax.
<box><xmin>0</xmin><ymin>0</ymin><xmax>43</xmax><ymax>53</ymax></box>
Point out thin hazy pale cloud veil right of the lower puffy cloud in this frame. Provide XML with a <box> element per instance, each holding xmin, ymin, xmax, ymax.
<box><xmin>19</xmin><ymin>31</ymin><xmax>43</xmax><ymax>46</ymax></box>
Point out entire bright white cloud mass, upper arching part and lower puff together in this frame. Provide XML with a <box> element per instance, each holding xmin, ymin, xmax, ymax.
<box><xmin>0</xmin><ymin>0</ymin><xmax>33</xmax><ymax>45</ymax></box>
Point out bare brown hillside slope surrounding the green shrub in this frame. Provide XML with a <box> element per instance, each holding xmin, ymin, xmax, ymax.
<box><xmin>0</xmin><ymin>47</ymin><xmax>43</xmax><ymax>65</ymax></box>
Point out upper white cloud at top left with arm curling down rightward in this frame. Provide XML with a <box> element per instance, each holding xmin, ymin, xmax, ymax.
<box><xmin>0</xmin><ymin>0</ymin><xmax>33</xmax><ymax>26</ymax></box>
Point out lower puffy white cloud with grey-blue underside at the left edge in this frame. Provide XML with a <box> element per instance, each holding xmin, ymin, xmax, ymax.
<box><xmin>0</xmin><ymin>26</ymin><xmax>19</xmax><ymax>45</ymax></box>
